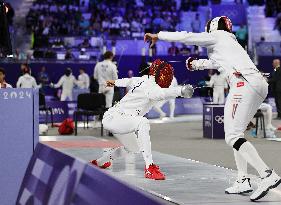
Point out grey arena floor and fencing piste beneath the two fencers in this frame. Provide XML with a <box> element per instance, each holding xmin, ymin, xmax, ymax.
<box><xmin>41</xmin><ymin>116</ymin><xmax>281</xmax><ymax>205</ymax></box>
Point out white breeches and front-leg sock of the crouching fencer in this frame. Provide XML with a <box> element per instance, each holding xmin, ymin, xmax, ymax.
<box><xmin>102</xmin><ymin>111</ymin><xmax>153</xmax><ymax>167</ymax></box>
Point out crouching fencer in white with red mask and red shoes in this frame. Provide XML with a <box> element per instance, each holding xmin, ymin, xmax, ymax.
<box><xmin>91</xmin><ymin>59</ymin><xmax>193</xmax><ymax>180</ymax></box>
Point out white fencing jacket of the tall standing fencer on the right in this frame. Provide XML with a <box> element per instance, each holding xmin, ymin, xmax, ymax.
<box><xmin>158</xmin><ymin>30</ymin><xmax>258</xmax><ymax>77</ymax></box>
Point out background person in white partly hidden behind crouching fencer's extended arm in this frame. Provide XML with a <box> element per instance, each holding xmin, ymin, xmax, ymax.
<box><xmin>153</xmin><ymin>76</ymin><xmax>178</xmax><ymax>118</ymax></box>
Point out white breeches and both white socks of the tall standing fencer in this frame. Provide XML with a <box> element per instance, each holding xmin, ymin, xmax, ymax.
<box><xmin>224</xmin><ymin>73</ymin><xmax>268</xmax><ymax>179</ymax></box>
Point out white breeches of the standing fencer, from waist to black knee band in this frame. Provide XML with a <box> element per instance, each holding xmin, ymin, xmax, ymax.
<box><xmin>224</xmin><ymin>74</ymin><xmax>268</xmax><ymax>146</ymax></box>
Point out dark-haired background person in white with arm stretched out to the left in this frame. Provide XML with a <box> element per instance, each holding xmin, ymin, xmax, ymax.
<box><xmin>51</xmin><ymin>68</ymin><xmax>77</xmax><ymax>101</ymax></box>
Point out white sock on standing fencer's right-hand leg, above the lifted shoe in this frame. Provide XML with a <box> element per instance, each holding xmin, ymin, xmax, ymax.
<box><xmin>238</xmin><ymin>141</ymin><xmax>269</xmax><ymax>177</ymax></box>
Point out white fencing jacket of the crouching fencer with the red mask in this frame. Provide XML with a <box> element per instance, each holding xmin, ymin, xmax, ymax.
<box><xmin>109</xmin><ymin>75</ymin><xmax>181</xmax><ymax>116</ymax></box>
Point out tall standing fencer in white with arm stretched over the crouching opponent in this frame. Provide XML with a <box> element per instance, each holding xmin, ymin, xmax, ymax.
<box><xmin>144</xmin><ymin>16</ymin><xmax>281</xmax><ymax>201</ymax></box>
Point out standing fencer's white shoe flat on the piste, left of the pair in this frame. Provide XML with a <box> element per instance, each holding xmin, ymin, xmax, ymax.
<box><xmin>225</xmin><ymin>178</ymin><xmax>253</xmax><ymax>194</ymax></box>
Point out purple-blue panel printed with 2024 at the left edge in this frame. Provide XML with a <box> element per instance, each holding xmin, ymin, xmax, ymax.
<box><xmin>0</xmin><ymin>88</ymin><xmax>39</xmax><ymax>205</ymax></box>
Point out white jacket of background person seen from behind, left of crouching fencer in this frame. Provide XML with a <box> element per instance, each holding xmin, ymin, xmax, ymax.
<box><xmin>94</xmin><ymin>60</ymin><xmax>118</xmax><ymax>85</ymax></box>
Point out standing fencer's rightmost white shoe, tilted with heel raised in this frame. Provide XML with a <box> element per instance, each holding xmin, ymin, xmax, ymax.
<box><xmin>250</xmin><ymin>170</ymin><xmax>281</xmax><ymax>201</ymax></box>
